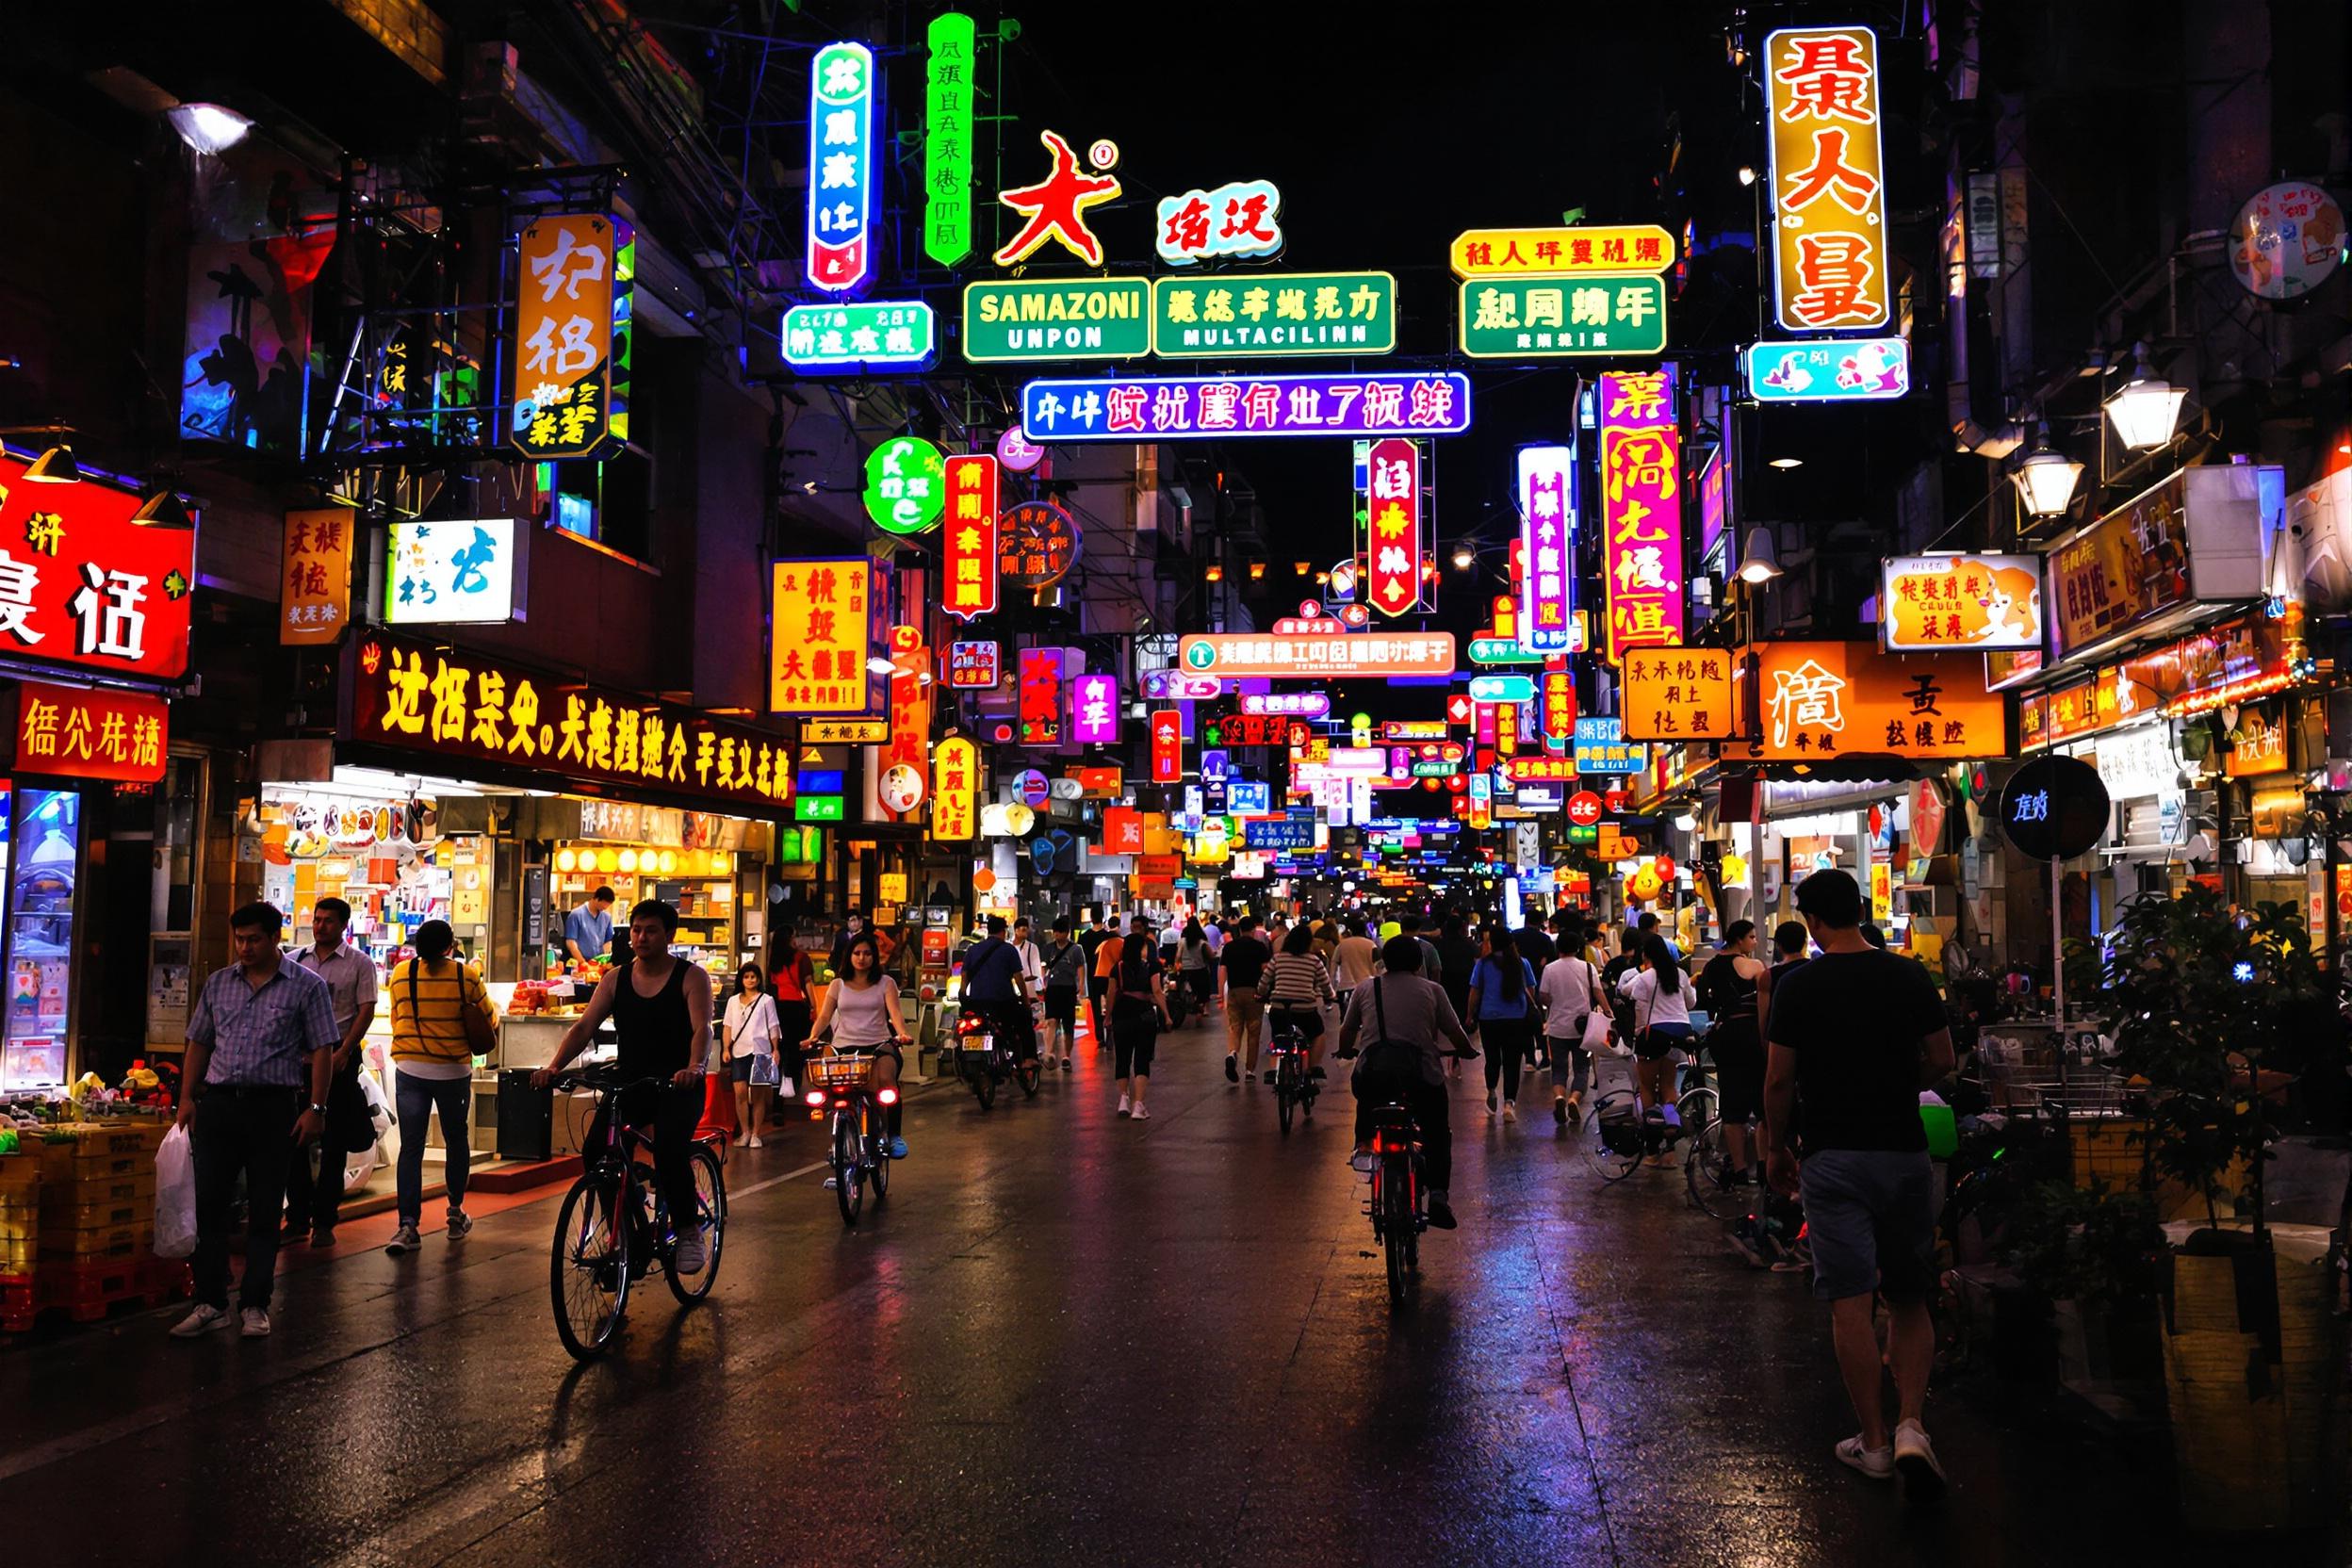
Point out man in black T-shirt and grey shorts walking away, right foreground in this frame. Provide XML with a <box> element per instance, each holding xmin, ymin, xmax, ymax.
<box><xmin>1764</xmin><ymin>873</ymin><xmax>1952</xmax><ymax>1502</ymax></box>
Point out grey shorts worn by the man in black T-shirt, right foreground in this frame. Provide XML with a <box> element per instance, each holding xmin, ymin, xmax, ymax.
<box><xmin>1799</xmin><ymin>1150</ymin><xmax>1936</xmax><ymax>1302</ymax></box>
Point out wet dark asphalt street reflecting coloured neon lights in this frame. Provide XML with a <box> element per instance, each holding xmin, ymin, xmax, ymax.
<box><xmin>0</xmin><ymin>1030</ymin><xmax>2281</xmax><ymax>1568</ymax></box>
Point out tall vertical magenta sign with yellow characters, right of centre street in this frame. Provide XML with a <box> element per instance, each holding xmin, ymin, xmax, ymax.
<box><xmin>1599</xmin><ymin>369</ymin><xmax>1684</xmax><ymax>663</ymax></box>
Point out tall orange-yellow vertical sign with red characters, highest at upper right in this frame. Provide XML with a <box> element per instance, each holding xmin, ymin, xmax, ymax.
<box><xmin>1764</xmin><ymin>28</ymin><xmax>1891</xmax><ymax>332</ymax></box>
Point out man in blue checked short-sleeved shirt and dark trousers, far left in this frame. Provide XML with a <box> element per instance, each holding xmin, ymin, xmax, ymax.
<box><xmin>172</xmin><ymin>903</ymin><xmax>343</xmax><ymax>1340</ymax></box>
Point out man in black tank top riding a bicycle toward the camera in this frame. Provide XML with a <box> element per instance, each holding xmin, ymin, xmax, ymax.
<box><xmin>531</xmin><ymin>898</ymin><xmax>710</xmax><ymax>1274</ymax></box>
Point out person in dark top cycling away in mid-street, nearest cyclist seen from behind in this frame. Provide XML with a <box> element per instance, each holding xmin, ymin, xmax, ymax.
<box><xmin>1338</xmin><ymin>936</ymin><xmax>1477</xmax><ymax>1230</ymax></box>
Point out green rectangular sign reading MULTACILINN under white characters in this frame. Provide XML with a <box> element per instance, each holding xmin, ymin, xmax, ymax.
<box><xmin>1152</xmin><ymin>272</ymin><xmax>1397</xmax><ymax>360</ymax></box>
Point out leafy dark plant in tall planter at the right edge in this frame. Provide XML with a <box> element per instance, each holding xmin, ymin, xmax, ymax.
<box><xmin>2096</xmin><ymin>887</ymin><xmax>2343</xmax><ymax>1530</ymax></box>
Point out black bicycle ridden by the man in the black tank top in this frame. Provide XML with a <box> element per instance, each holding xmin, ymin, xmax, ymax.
<box><xmin>548</xmin><ymin>1072</ymin><xmax>727</xmax><ymax>1361</ymax></box>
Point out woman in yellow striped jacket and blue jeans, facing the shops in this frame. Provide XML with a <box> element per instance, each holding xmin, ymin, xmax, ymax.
<box><xmin>384</xmin><ymin>919</ymin><xmax>498</xmax><ymax>1253</ymax></box>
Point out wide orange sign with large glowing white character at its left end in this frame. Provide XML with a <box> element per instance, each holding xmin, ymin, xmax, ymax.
<box><xmin>1726</xmin><ymin>642</ymin><xmax>2009</xmax><ymax>761</ymax></box>
